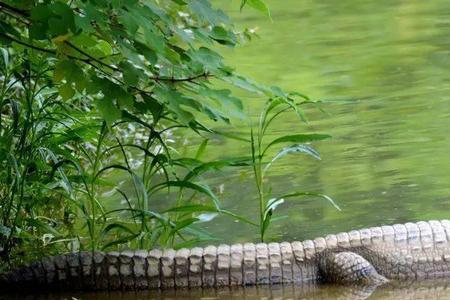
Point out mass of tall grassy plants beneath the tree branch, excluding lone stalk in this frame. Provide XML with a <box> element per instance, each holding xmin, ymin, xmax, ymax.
<box><xmin>0</xmin><ymin>49</ymin><xmax>251</xmax><ymax>265</ymax></box>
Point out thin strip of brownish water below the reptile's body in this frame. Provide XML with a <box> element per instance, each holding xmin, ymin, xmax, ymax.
<box><xmin>4</xmin><ymin>282</ymin><xmax>450</xmax><ymax>300</ymax></box>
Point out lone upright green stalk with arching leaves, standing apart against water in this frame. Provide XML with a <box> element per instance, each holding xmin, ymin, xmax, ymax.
<box><xmin>250</xmin><ymin>93</ymin><xmax>340</xmax><ymax>241</ymax></box>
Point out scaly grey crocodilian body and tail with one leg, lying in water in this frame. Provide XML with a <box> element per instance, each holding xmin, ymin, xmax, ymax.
<box><xmin>0</xmin><ymin>220</ymin><xmax>450</xmax><ymax>291</ymax></box>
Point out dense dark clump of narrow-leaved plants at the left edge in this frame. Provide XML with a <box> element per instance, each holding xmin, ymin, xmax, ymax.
<box><xmin>0</xmin><ymin>48</ymin><xmax>81</xmax><ymax>268</ymax></box>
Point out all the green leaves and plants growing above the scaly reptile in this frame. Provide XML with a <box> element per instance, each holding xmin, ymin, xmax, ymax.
<box><xmin>0</xmin><ymin>0</ymin><xmax>332</xmax><ymax>268</ymax></box>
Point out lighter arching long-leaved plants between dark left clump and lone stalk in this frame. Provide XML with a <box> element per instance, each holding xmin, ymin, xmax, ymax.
<box><xmin>71</xmin><ymin>119</ymin><xmax>256</xmax><ymax>250</ymax></box>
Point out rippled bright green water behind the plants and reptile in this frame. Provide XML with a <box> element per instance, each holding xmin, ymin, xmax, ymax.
<box><xmin>184</xmin><ymin>0</ymin><xmax>450</xmax><ymax>242</ymax></box>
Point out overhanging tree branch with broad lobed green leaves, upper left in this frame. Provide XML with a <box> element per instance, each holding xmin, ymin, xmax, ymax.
<box><xmin>0</xmin><ymin>0</ymin><xmax>273</xmax><ymax>130</ymax></box>
